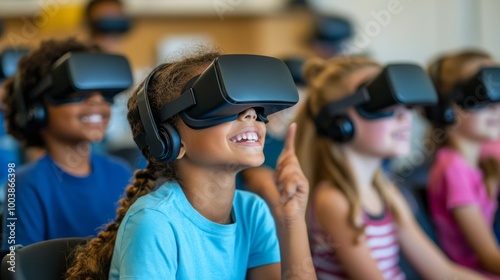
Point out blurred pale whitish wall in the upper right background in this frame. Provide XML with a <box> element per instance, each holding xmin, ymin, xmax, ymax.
<box><xmin>308</xmin><ymin>0</ymin><xmax>500</xmax><ymax>64</ymax></box>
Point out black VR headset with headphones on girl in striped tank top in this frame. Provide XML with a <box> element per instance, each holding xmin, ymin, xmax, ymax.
<box><xmin>313</xmin><ymin>64</ymin><xmax>437</xmax><ymax>143</ymax></box>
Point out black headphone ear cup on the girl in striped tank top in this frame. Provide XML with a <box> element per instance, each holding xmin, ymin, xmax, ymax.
<box><xmin>315</xmin><ymin>114</ymin><xmax>355</xmax><ymax>143</ymax></box>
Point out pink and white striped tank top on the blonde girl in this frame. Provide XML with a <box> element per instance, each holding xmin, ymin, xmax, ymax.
<box><xmin>310</xmin><ymin>205</ymin><xmax>406</xmax><ymax>280</ymax></box>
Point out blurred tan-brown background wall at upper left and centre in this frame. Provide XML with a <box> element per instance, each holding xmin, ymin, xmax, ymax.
<box><xmin>0</xmin><ymin>3</ymin><xmax>313</xmax><ymax>68</ymax></box>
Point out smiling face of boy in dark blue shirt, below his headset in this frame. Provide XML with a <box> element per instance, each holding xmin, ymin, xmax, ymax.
<box><xmin>42</xmin><ymin>92</ymin><xmax>111</xmax><ymax>143</ymax></box>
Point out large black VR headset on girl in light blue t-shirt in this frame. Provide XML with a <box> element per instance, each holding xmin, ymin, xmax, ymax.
<box><xmin>134</xmin><ymin>55</ymin><xmax>299</xmax><ymax>162</ymax></box>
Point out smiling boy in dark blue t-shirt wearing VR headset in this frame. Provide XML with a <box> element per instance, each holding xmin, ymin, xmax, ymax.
<box><xmin>2</xmin><ymin>39</ymin><xmax>132</xmax><ymax>250</ymax></box>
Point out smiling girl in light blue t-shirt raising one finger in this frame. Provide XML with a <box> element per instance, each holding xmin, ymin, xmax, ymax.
<box><xmin>67</xmin><ymin>52</ymin><xmax>315</xmax><ymax>279</ymax></box>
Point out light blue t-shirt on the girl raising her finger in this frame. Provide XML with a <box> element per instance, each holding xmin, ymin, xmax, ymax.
<box><xmin>109</xmin><ymin>182</ymin><xmax>280</xmax><ymax>280</ymax></box>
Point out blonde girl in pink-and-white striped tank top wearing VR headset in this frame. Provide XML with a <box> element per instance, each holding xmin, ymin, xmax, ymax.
<box><xmin>295</xmin><ymin>57</ymin><xmax>481</xmax><ymax>279</ymax></box>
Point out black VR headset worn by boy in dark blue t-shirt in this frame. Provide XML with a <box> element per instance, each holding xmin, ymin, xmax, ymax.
<box><xmin>14</xmin><ymin>52</ymin><xmax>133</xmax><ymax>130</ymax></box>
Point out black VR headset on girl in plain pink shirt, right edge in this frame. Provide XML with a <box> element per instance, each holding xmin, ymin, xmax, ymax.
<box><xmin>425</xmin><ymin>67</ymin><xmax>500</xmax><ymax>126</ymax></box>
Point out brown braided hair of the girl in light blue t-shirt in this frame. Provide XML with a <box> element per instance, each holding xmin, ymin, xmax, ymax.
<box><xmin>66</xmin><ymin>51</ymin><xmax>220</xmax><ymax>279</ymax></box>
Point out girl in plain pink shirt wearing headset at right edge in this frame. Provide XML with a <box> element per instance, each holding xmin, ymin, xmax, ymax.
<box><xmin>426</xmin><ymin>50</ymin><xmax>500</xmax><ymax>279</ymax></box>
